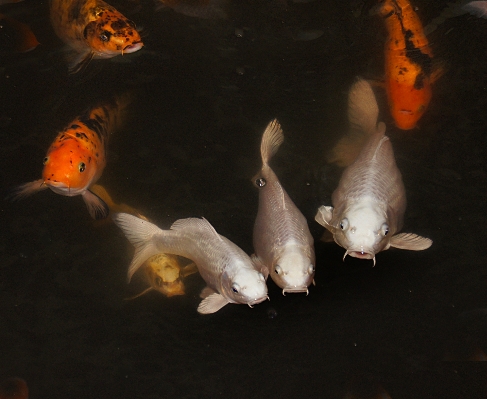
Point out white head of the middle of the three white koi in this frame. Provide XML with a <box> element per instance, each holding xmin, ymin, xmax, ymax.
<box><xmin>270</xmin><ymin>246</ymin><xmax>315</xmax><ymax>295</ymax></box>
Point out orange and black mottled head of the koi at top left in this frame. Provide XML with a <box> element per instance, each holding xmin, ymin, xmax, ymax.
<box><xmin>83</xmin><ymin>7</ymin><xmax>144</xmax><ymax>58</ymax></box>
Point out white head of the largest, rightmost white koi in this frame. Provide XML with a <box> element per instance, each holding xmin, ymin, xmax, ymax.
<box><xmin>334</xmin><ymin>206</ymin><xmax>393</xmax><ymax>265</ymax></box>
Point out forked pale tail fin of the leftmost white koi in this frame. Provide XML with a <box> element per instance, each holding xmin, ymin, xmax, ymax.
<box><xmin>112</xmin><ymin>213</ymin><xmax>162</xmax><ymax>282</ymax></box>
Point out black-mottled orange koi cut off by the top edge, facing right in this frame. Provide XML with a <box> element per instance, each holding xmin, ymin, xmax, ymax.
<box><xmin>50</xmin><ymin>0</ymin><xmax>143</xmax><ymax>73</ymax></box>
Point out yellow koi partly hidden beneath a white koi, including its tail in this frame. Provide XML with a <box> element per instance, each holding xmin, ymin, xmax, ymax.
<box><xmin>90</xmin><ymin>184</ymin><xmax>198</xmax><ymax>299</ymax></box>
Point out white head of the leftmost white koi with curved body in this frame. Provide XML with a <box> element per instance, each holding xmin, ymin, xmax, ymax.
<box><xmin>222</xmin><ymin>268</ymin><xmax>269</xmax><ymax>307</ymax></box>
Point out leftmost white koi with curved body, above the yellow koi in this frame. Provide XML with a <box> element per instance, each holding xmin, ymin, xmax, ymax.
<box><xmin>112</xmin><ymin>213</ymin><xmax>268</xmax><ymax>314</ymax></box>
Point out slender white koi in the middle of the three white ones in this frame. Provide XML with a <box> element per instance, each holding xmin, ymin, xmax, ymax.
<box><xmin>253</xmin><ymin>119</ymin><xmax>315</xmax><ymax>294</ymax></box>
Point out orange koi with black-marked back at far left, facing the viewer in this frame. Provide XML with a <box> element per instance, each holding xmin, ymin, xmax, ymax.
<box><xmin>8</xmin><ymin>98</ymin><xmax>127</xmax><ymax>219</ymax></box>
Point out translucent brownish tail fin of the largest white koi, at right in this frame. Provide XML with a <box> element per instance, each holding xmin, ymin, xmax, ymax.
<box><xmin>328</xmin><ymin>78</ymin><xmax>379</xmax><ymax>167</ymax></box>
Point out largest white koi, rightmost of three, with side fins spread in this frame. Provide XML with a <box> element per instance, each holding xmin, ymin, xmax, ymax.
<box><xmin>315</xmin><ymin>80</ymin><xmax>432</xmax><ymax>265</ymax></box>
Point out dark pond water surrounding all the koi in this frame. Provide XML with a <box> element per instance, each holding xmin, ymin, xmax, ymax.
<box><xmin>0</xmin><ymin>0</ymin><xmax>487</xmax><ymax>399</ymax></box>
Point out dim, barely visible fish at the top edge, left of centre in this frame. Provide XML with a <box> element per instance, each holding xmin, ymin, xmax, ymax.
<box><xmin>158</xmin><ymin>0</ymin><xmax>228</xmax><ymax>19</ymax></box>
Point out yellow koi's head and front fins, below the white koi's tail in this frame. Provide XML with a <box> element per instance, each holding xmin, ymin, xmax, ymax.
<box><xmin>127</xmin><ymin>253</ymin><xmax>198</xmax><ymax>299</ymax></box>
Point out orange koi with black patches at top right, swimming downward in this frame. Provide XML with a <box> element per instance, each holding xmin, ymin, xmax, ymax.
<box><xmin>378</xmin><ymin>0</ymin><xmax>433</xmax><ymax>130</ymax></box>
